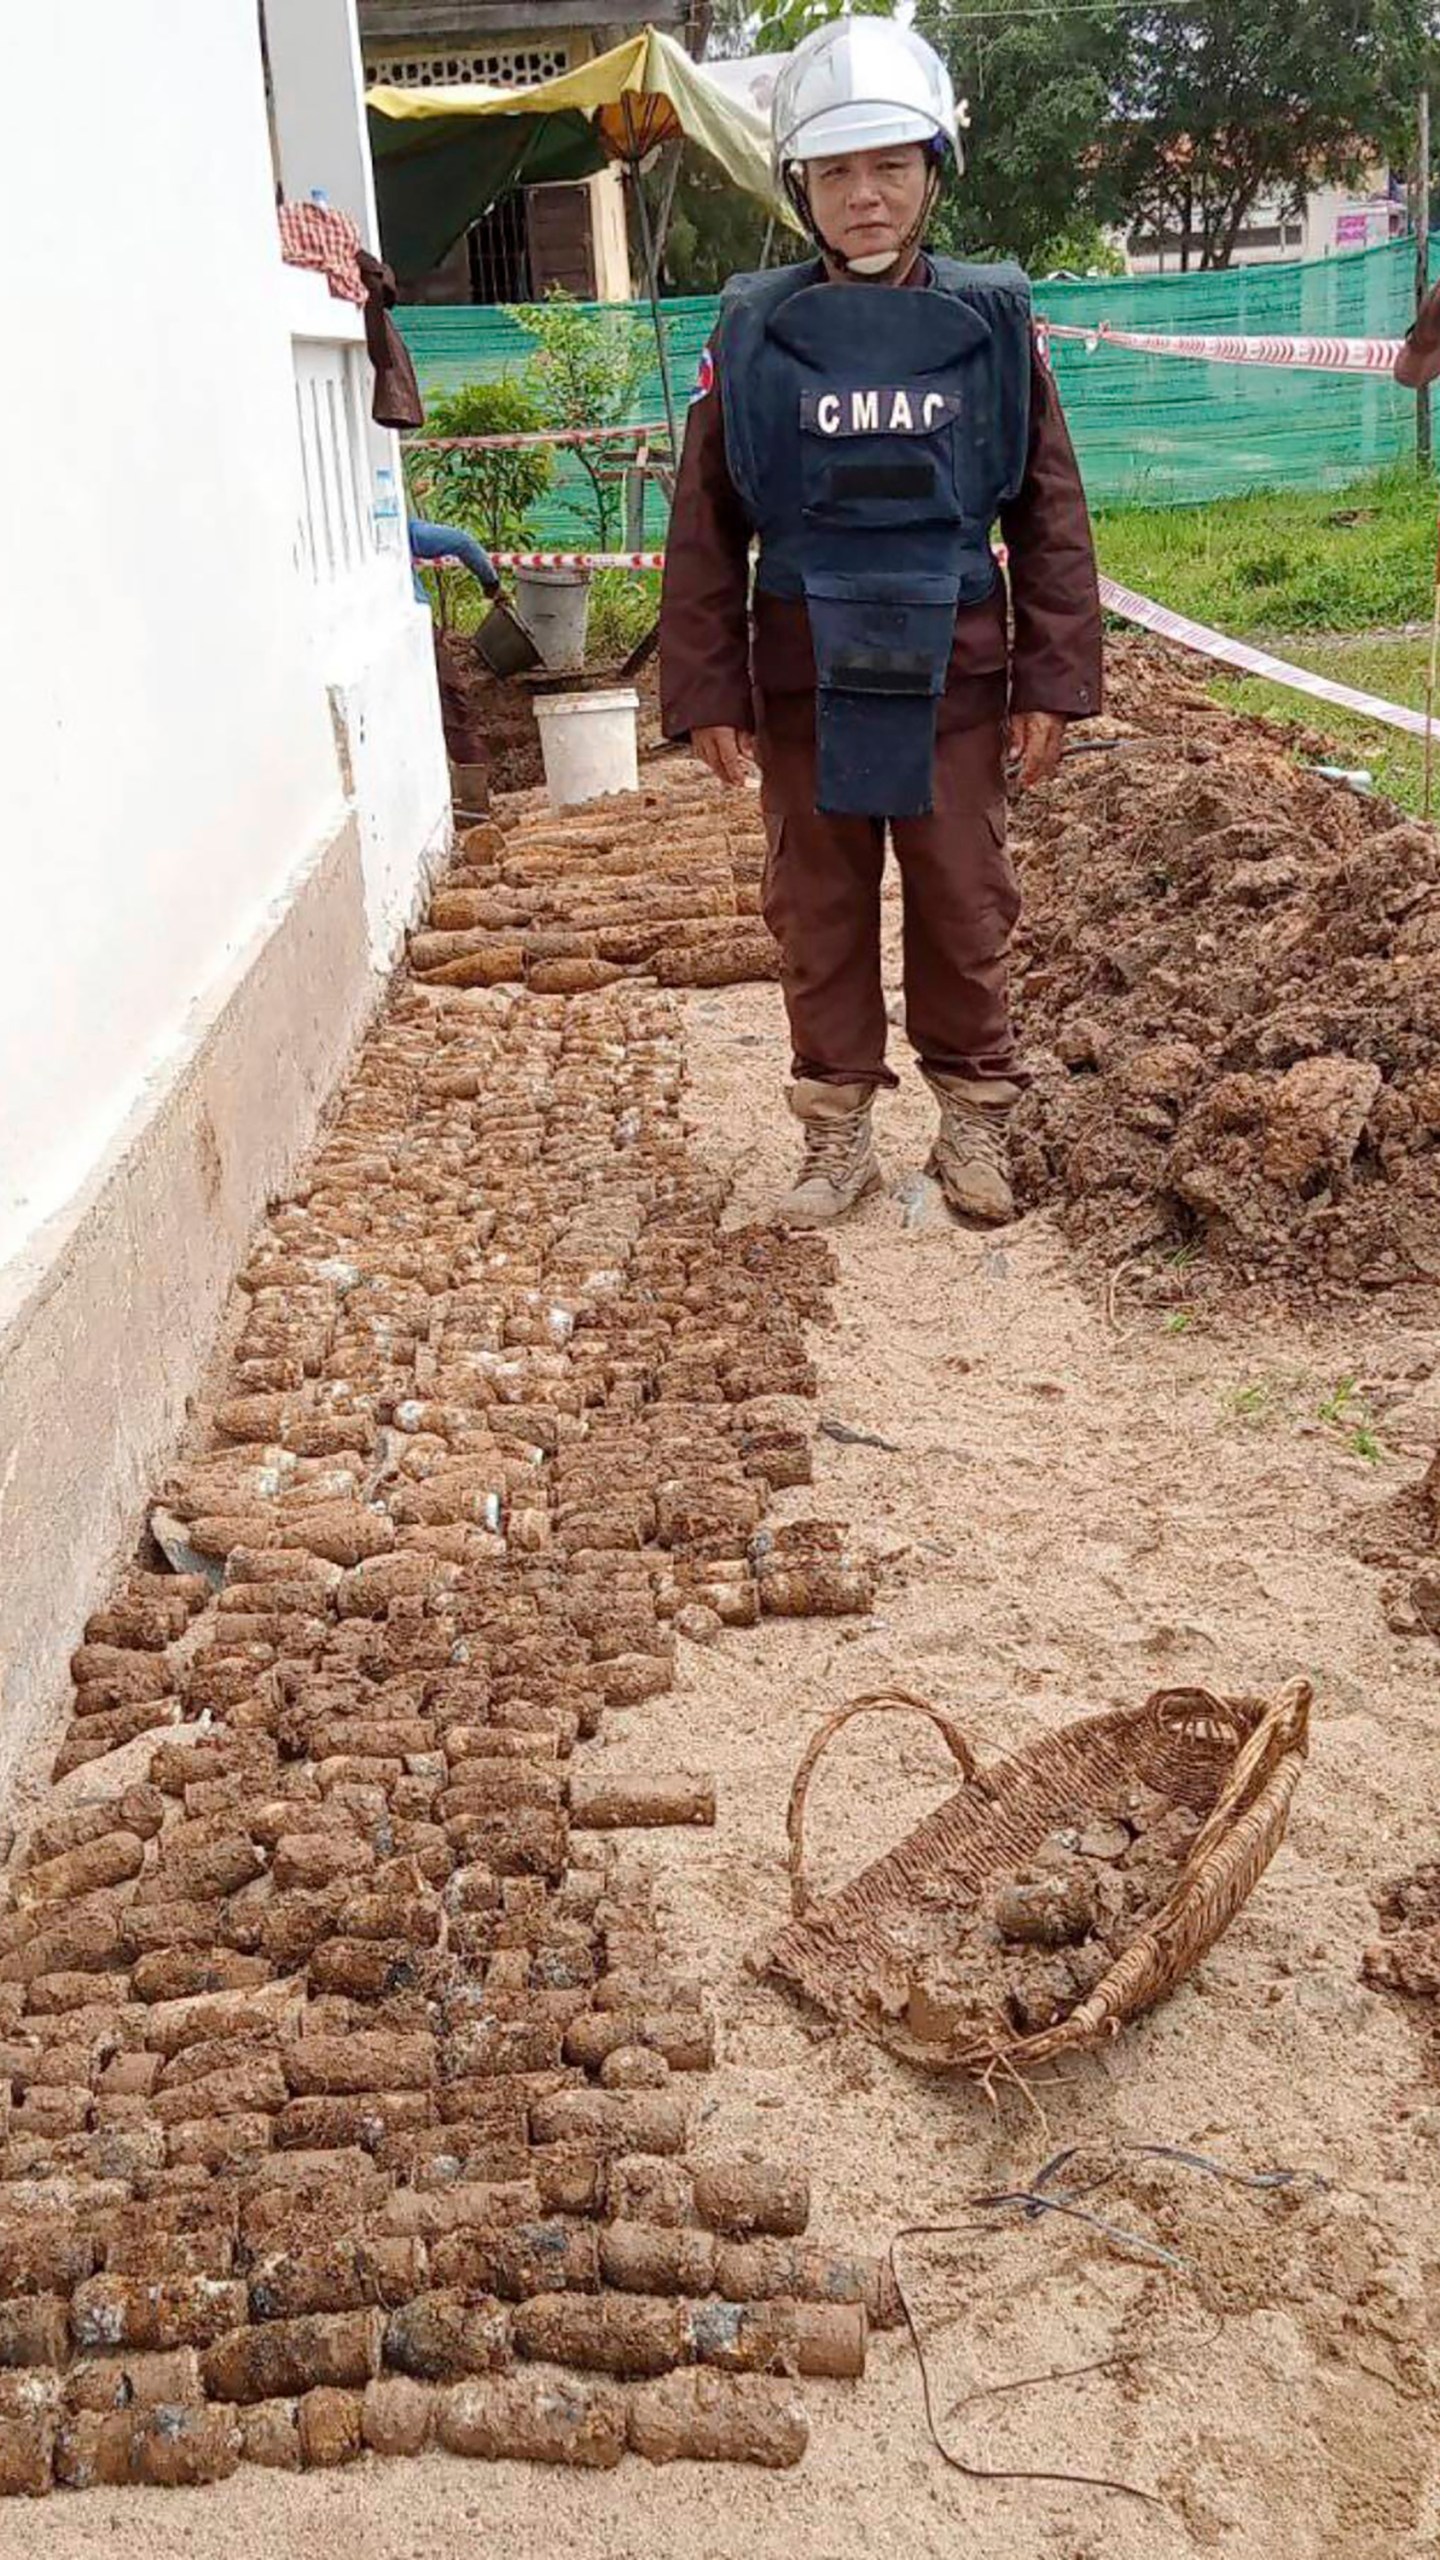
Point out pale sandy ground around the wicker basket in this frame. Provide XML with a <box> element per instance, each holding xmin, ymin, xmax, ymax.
<box><xmin>11</xmin><ymin>890</ymin><xmax>1440</xmax><ymax>2560</ymax></box>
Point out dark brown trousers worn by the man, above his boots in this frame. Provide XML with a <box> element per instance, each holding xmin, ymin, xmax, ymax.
<box><xmin>758</xmin><ymin>696</ymin><xmax>1022</xmax><ymax>1085</ymax></box>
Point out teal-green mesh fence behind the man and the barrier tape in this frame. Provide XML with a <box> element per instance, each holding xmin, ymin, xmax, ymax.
<box><xmin>397</xmin><ymin>241</ymin><xmax>1435</xmax><ymax>548</ymax></box>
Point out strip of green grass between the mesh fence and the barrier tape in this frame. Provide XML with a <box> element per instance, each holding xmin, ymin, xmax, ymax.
<box><xmin>1094</xmin><ymin>466</ymin><xmax>1435</xmax><ymax>635</ymax></box>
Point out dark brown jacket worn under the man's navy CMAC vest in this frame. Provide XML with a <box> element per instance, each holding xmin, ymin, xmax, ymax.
<box><xmin>661</xmin><ymin>269</ymin><xmax>1102</xmax><ymax>737</ymax></box>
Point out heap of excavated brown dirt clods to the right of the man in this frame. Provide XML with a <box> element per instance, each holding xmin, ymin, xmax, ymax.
<box><xmin>1017</xmin><ymin>643</ymin><xmax>1440</xmax><ymax>1295</ymax></box>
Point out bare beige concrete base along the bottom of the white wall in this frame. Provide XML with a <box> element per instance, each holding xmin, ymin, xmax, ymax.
<box><xmin>0</xmin><ymin>814</ymin><xmax>376</xmax><ymax>1784</ymax></box>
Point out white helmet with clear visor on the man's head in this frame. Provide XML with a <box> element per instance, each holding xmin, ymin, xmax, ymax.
<box><xmin>771</xmin><ymin>18</ymin><xmax>969</xmax><ymax>182</ymax></box>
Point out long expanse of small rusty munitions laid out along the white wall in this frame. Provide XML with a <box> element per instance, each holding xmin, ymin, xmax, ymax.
<box><xmin>0</xmin><ymin>817</ymin><xmax>887</xmax><ymax>2493</ymax></box>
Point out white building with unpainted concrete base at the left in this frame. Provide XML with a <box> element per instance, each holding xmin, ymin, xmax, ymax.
<box><xmin>0</xmin><ymin>0</ymin><xmax>448</xmax><ymax>1764</ymax></box>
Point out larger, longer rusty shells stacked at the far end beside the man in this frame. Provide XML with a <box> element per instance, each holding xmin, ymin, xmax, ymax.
<box><xmin>410</xmin><ymin>776</ymin><xmax>779</xmax><ymax>996</ymax></box>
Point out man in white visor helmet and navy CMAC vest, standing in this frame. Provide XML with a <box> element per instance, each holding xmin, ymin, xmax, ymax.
<box><xmin>661</xmin><ymin>18</ymin><xmax>1102</xmax><ymax>1226</ymax></box>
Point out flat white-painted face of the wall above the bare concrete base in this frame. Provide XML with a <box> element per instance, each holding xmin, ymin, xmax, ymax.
<box><xmin>0</xmin><ymin>0</ymin><xmax>356</xmax><ymax>1262</ymax></box>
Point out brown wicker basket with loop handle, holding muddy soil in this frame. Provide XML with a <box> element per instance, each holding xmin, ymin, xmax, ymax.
<box><xmin>756</xmin><ymin>1679</ymin><xmax>1312</xmax><ymax>2079</ymax></box>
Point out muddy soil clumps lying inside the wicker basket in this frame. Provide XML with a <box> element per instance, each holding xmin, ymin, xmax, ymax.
<box><xmin>887</xmin><ymin>1784</ymin><xmax>1199</xmax><ymax>2051</ymax></box>
